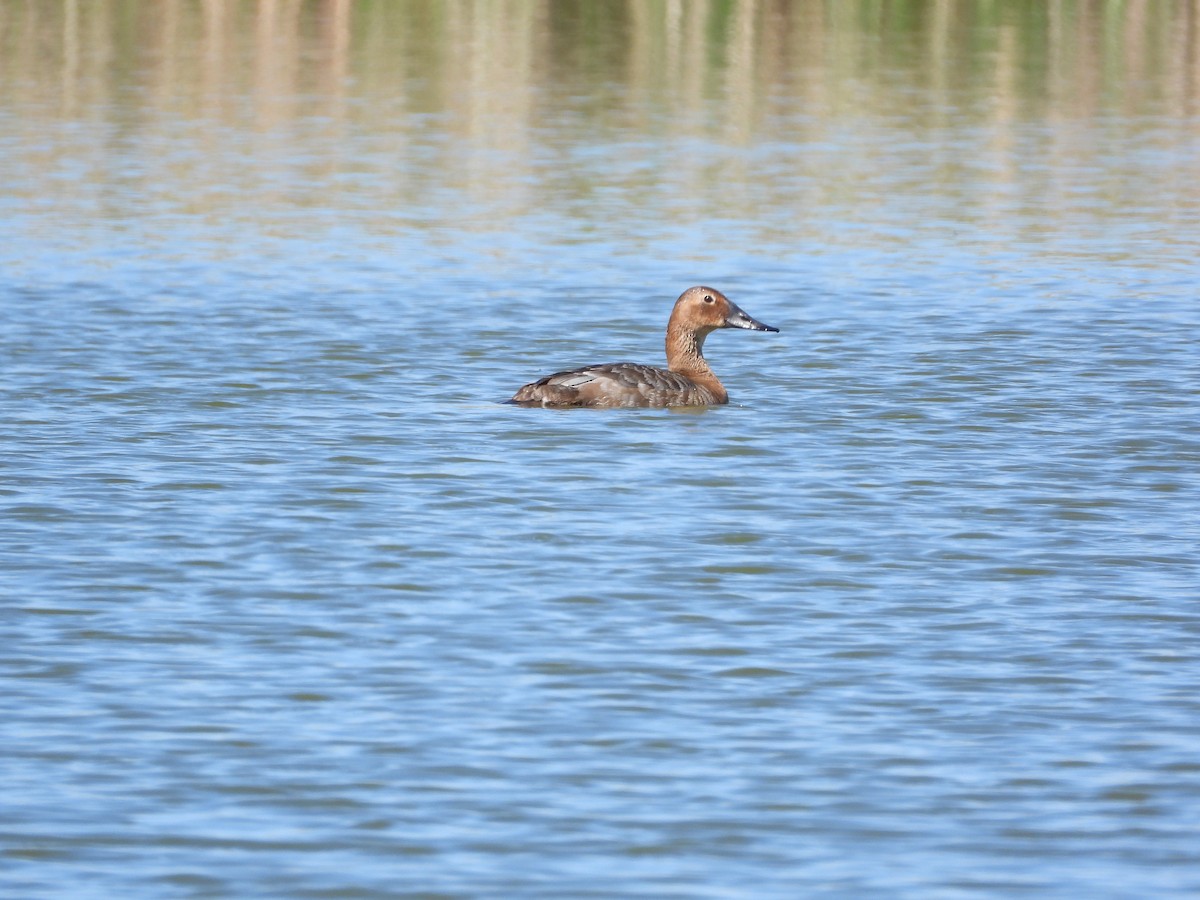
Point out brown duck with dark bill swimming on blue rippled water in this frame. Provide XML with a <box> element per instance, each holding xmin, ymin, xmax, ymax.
<box><xmin>508</xmin><ymin>284</ymin><xmax>779</xmax><ymax>408</ymax></box>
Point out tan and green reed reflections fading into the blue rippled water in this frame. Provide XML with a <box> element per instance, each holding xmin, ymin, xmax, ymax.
<box><xmin>0</xmin><ymin>0</ymin><xmax>1200</xmax><ymax>240</ymax></box>
